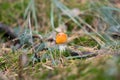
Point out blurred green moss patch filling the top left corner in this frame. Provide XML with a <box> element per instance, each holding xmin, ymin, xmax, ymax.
<box><xmin>0</xmin><ymin>0</ymin><xmax>28</xmax><ymax>24</ymax></box>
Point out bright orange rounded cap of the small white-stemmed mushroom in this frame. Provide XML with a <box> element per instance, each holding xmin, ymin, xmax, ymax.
<box><xmin>56</xmin><ymin>32</ymin><xmax>67</xmax><ymax>44</ymax></box>
